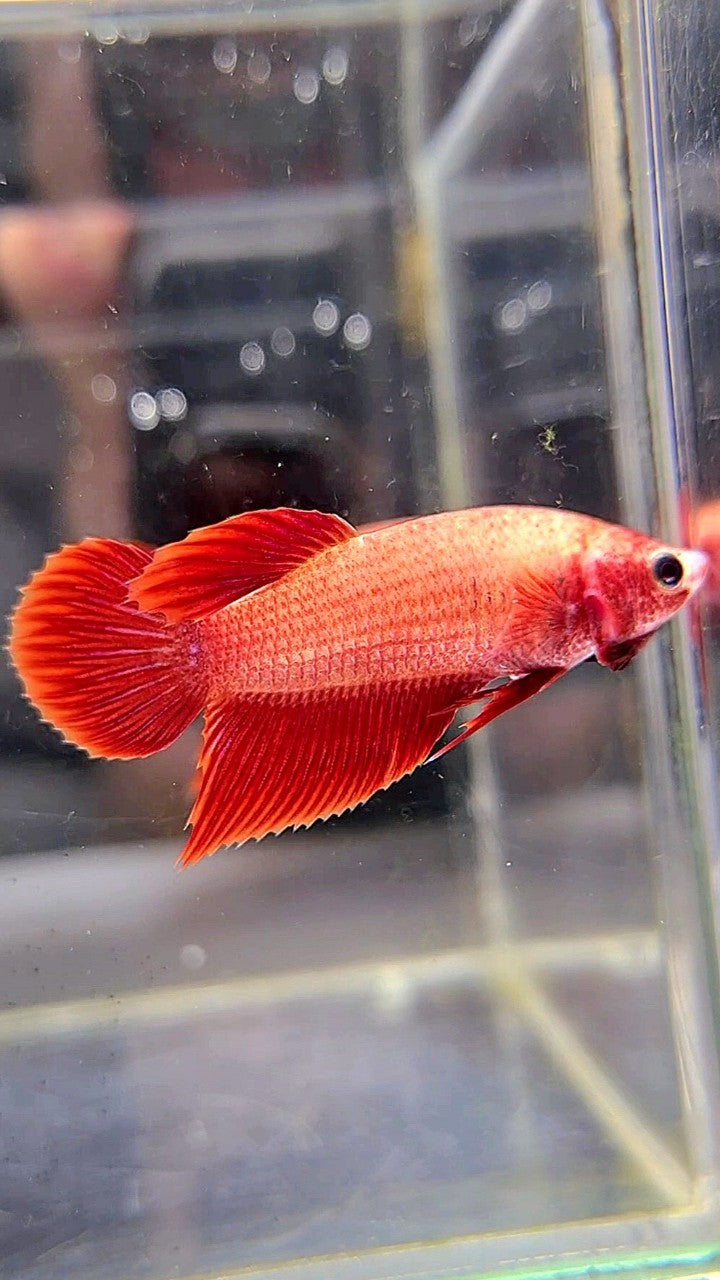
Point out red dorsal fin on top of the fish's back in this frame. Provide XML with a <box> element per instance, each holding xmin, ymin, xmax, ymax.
<box><xmin>128</xmin><ymin>507</ymin><xmax>357</xmax><ymax>622</ymax></box>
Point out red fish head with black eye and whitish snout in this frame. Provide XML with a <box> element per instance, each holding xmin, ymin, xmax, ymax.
<box><xmin>582</xmin><ymin>526</ymin><xmax>708</xmax><ymax>671</ymax></box>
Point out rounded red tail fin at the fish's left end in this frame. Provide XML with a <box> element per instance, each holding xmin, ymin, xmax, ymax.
<box><xmin>9</xmin><ymin>538</ymin><xmax>204</xmax><ymax>759</ymax></box>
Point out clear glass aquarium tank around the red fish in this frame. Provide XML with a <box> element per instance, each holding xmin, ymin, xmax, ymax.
<box><xmin>0</xmin><ymin>0</ymin><xmax>720</xmax><ymax>1280</ymax></box>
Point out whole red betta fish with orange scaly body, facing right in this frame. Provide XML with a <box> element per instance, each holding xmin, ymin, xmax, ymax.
<box><xmin>10</xmin><ymin>507</ymin><xmax>706</xmax><ymax>863</ymax></box>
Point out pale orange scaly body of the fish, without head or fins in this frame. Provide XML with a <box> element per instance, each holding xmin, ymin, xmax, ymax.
<box><xmin>201</xmin><ymin>508</ymin><xmax>591</xmax><ymax>696</ymax></box>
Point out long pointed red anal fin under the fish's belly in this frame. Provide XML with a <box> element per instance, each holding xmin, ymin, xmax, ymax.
<box><xmin>179</xmin><ymin>684</ymin><xmax>466</xmax><ymax>865</ymax></box>
